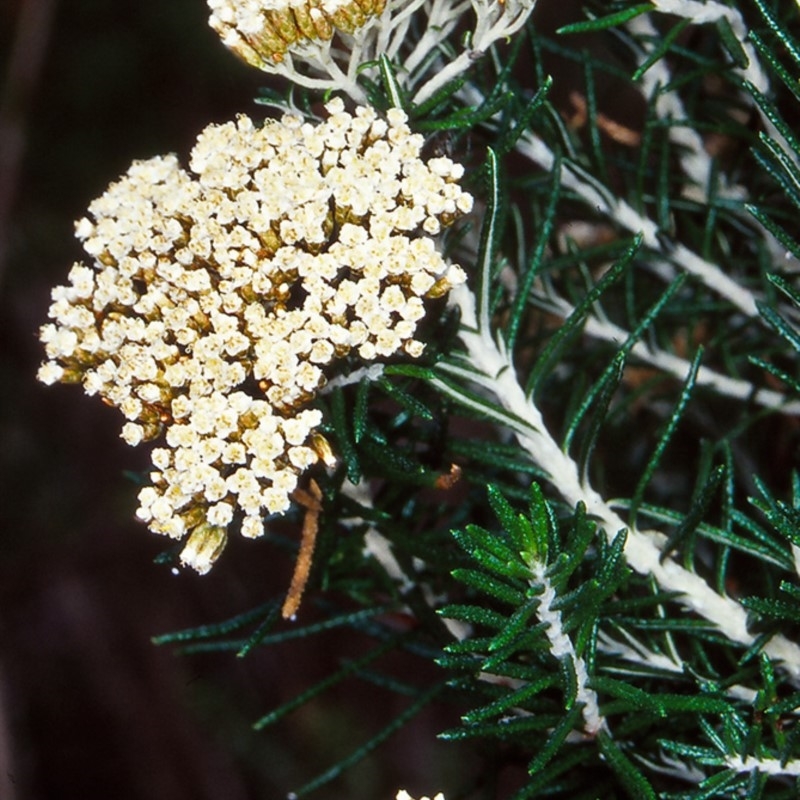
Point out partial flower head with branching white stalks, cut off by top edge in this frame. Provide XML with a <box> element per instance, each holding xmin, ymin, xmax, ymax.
<box><xmin>207</xmin><ymin>0</ymin><xmax>536</xmax><ymax>104</ymax></box>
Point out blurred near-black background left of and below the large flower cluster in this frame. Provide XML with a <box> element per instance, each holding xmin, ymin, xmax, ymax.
<box><xmin>0</xmin><ymin>0</ymin><xmax>468</xmax><ymax>800</ymax></box>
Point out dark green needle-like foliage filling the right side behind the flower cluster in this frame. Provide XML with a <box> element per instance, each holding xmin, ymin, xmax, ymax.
<box><xmin>145</xmin><ymin>0</ymin><xmax>800</xmax><ymax>800</ymax></box>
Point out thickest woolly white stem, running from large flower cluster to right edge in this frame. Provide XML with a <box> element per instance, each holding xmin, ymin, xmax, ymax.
<box><xmin>435</xmin><ymin>286</ymin><xmax>800</xmax><ymax>682</ymax></box>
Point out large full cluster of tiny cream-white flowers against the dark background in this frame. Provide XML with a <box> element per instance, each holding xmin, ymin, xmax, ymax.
<box><xmin>39</xmin><ymin>99</ymin><xmax>472</xmax><ymax>572</ymax></box>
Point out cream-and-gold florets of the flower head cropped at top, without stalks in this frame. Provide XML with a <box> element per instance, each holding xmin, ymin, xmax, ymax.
<box><xmin>208</xmin><ymin>0</ymin><xmax>386</xmax><ymax>68</ymax></box>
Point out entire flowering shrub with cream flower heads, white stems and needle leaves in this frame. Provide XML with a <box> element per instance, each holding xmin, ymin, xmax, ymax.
<box><xmin>39</xmin><ymin>0</ymin><xmax>800</xmax><ymax>800</ymax></box>
